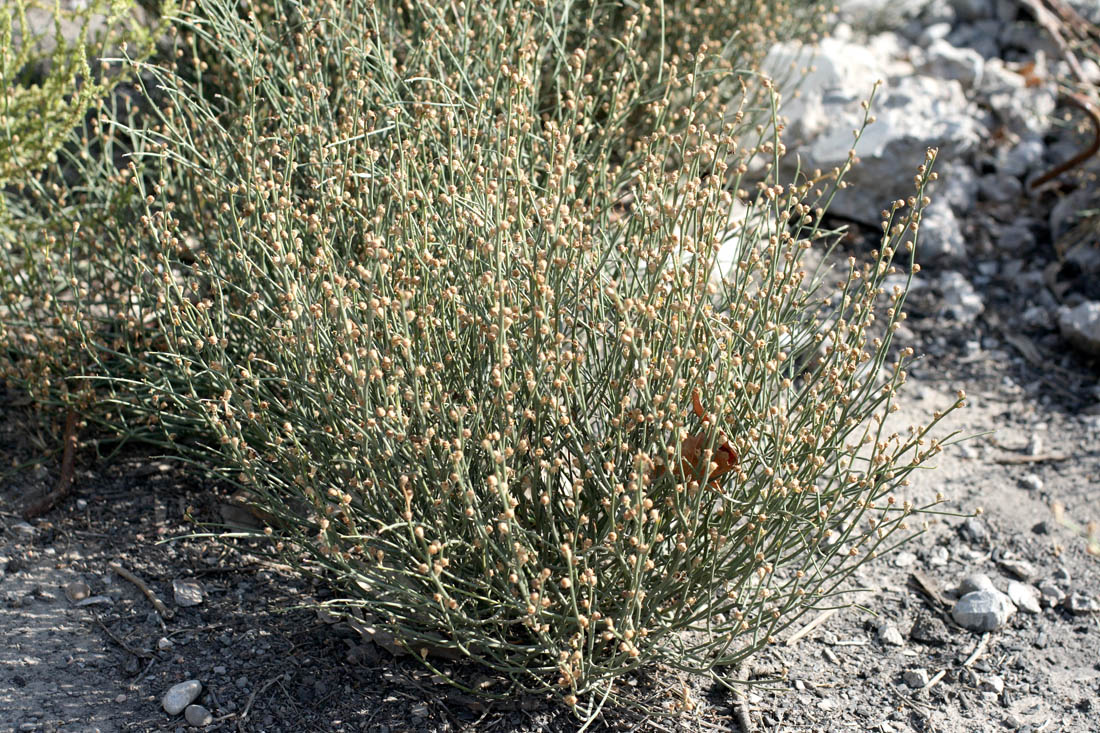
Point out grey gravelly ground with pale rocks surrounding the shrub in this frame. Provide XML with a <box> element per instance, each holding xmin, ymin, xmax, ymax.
<box><xmin>0</xmin><ymin>0</ymin><xmax>1100</xmax><ymax>733</ymax></box>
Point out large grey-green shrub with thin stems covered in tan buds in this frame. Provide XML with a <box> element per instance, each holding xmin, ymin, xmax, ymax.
<box><xmin>0</xmin><ymin>0</ymin><xmax>961</xmax><ymax>719</ymax></box>
